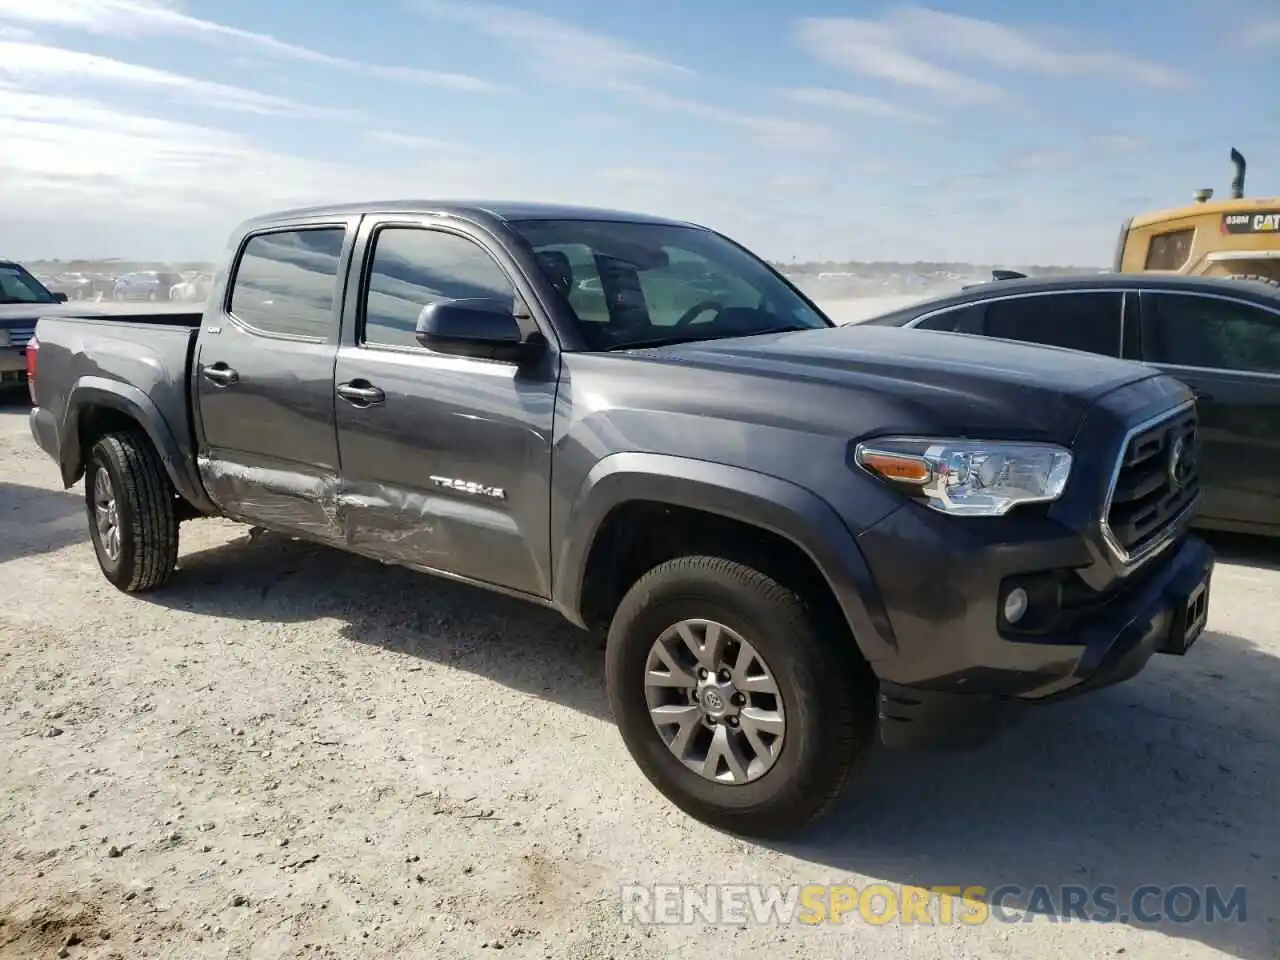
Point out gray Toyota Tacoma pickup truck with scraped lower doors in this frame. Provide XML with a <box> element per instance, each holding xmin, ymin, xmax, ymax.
<box><xmin>31</xmin><ymin>202</ymin><xmax>1213</xmax><ymax>836</ymax></box>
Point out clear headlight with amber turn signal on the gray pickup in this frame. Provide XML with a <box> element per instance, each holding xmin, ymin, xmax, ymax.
<box><xmin>855</xmin><ymin>436</ymin><xmax>1071</xmax><ymax>517</ymax></box>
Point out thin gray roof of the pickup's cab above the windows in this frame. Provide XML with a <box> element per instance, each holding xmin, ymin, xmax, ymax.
<box><xmin>242</xmin><ymin>200</ymin><xmax>698</xmax><ymax>229</ymax></box>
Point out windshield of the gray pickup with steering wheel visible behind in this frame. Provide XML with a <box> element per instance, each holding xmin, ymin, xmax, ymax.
<box><xmin>511</xmin><ymin>220</ymin><xmax>831</xmax><ymax>349</ymax></box>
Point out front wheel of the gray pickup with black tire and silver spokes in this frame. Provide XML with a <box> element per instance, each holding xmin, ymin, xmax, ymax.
<box><xmin>605</xmin><ymin>557</ymin><xmax>877</xmax><ymax>838</ymax></box>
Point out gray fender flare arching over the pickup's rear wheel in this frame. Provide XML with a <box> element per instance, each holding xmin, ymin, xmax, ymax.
<box><xmin>59</xmin><ymin>376</ymin><xmax>218</xmax><ymax>513</ymax></box>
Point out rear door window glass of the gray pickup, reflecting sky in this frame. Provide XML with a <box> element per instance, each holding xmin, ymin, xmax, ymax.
<box><xmin>228</xmin><ymin>225</ymin><xmax>347</xmax><ymax>340</ymax></box>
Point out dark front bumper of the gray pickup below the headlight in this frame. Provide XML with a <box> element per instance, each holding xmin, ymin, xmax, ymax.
<box><xmin>860</xmin><ymin>511</ymin><xmax>1215</xmax><ymax>748</ymax></box>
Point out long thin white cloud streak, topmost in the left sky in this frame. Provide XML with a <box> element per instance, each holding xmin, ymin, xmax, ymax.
<box><xmin>0</xmin><ymin>0</ymin><xmax>500</xmax><ymax>92</ymax></box>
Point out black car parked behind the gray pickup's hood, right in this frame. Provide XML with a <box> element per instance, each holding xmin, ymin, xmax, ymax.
<box><xmin>864</xmin><ymin>274</ymin><xmax>1280</xmax><ymax>536</ymax></box>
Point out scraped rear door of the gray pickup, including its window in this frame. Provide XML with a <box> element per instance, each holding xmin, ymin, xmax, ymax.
<box><xmin>192</xmin><ymin>220</ymin><xmax>356</xmax><ymax>544</ymax></box>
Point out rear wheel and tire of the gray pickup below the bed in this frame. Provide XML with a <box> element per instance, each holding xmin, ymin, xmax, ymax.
<box><xmin>84</xmin><ymin>431</ymin><xmax>178</xmax><ymax>593</ymax></box>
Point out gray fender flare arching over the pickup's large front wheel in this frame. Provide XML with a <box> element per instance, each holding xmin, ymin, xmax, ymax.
<box><xmin>553</xmin><ymin>453</ymin><xmax>897</xmax><ymax>663</ymax></box>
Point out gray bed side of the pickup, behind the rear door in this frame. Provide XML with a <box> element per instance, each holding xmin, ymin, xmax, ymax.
<box><xmin>31</xmin><ymin>311</ymin><xmax>215</xmax><ymax>512</ymax></box>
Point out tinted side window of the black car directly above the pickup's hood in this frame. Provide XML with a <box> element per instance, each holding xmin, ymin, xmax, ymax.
<box><xmin>983</xmin><ymin>291</ymin><xmax>1124</xmax><ymax>357</ymax></box>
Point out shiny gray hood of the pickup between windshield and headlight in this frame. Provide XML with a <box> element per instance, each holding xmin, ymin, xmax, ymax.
<box><xmin>634</xmin><ymin>325</ymin><xmax>1161</xmax><ymax>443</ymax></box>
